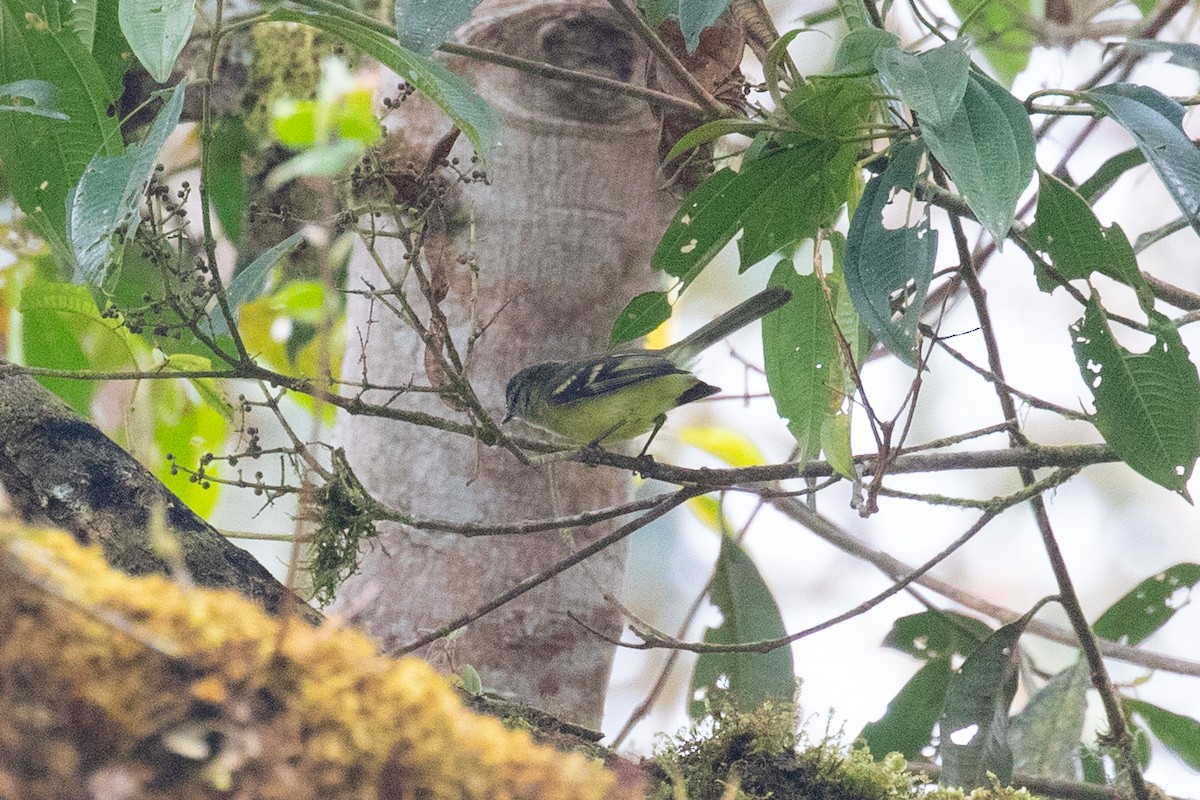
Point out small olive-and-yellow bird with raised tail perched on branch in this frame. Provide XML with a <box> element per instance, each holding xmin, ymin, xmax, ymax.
<box><xmin>504</xmin><ymin>287</ymin><xmax>792</xmax><ymax>456</ymax></box>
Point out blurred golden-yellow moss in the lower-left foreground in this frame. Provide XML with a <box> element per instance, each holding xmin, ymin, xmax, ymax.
<box><xmin>0</xmin><ymin>524</ymin><xmax>633</xmax><ymax>800</ymax></box>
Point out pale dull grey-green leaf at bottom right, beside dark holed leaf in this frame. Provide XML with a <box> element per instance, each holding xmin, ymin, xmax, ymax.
<box><xmin>1008</xmin><ymin>658</ymin><xmax>1092</xmax><ymax>781</ymax></box>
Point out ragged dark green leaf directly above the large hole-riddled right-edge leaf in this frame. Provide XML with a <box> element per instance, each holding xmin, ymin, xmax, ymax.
<box><xmin>1028</xmin><ymin>173</ymin><xmax>1153</xmax><ymax>293</ymax></box>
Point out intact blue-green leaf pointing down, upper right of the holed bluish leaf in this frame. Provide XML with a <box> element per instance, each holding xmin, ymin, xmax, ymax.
<box><xmin>920</xmin><ymin>71</ymin><xmax>1037</xmax><ymax>245</ymax></box>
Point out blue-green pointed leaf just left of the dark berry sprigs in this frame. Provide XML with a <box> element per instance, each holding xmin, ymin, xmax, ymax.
<box><xmin>67</xmin><ymin>82</ymin><xmax>185</xmax><ymax>288</ymax></box>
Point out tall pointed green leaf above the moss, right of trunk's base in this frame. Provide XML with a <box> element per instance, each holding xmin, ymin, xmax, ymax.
<box><xmin>690</xmin><ymin>536</ymin><xmax>796</xmax><ymax>718</ymax></box>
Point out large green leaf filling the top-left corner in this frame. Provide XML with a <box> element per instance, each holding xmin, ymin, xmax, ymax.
<box><xmin>0</xmin><ymin>0</ymin><xmax>122</xmax><ymax>265</ymax></box>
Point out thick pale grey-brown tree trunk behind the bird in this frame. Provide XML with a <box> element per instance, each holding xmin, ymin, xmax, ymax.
<box><xmin>335</xmin><ymin>1</ymin><xmax>673</xmax><ymax>726</ymax></box>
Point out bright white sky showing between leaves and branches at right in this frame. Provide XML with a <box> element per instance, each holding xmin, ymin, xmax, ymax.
<box><xmin>605</xmin><ymin>4</ymin><xmax>1200</xmax><ymax>796</ymax></box>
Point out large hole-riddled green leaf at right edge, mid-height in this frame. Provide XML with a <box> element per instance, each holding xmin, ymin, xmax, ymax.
<box><xmin>1070</xmin><ymin>297</ymin><xmax>1200</xmax><ymax>503</ymax></box>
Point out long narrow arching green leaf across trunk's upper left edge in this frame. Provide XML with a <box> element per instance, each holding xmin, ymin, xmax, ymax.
<box><xmin>271</xmin><ymin>8</ymin><xmax>500</xmax><ymax>169</ymax></box>
